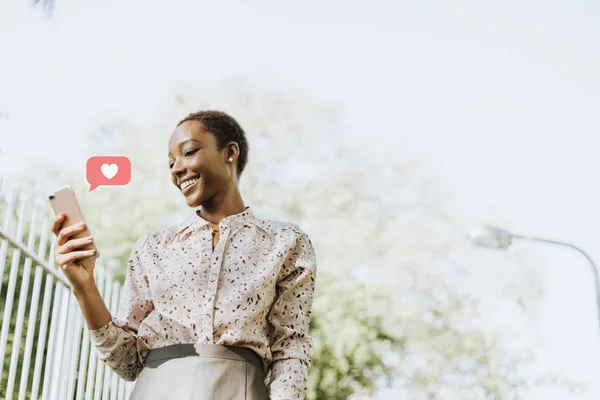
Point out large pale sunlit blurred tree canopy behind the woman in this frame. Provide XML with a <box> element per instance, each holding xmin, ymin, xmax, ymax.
<box><xmin>19</xmin><ymin>80</ymin><xmax>556</xmax><ymax>400</ymax></box>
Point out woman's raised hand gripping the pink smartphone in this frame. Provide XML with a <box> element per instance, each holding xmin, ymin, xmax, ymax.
<box><xmin>52</xmin><ymin>213</ymin><xmax>96</xmax><ymax>291</ymax></box>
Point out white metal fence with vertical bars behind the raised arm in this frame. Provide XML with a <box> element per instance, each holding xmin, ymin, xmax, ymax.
<box><xmin>0</xmin><ymin>181</ymin><xmax>133</xmax><ymax>400</ymax></box>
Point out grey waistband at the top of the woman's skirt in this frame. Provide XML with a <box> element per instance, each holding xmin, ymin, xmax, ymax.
<box><xmin>144</xmin><ymin>343</ymin><xmax>263</xmax><ymax>370</ymax></box>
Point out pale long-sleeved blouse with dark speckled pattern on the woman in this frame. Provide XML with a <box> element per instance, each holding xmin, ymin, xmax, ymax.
<box><xmin>90</xmin><ymin>208</ymin><xmax>316</xmax><ymax>400</ymax></box>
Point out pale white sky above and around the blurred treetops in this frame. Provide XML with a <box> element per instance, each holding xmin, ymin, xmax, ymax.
<box><xmin>0</xmin><ymin>0</ymin><xmax>600</xmax><ymax>400</ymax></box>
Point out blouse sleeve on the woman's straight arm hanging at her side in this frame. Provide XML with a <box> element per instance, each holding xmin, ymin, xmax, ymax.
<box><xmin>268</xmin><ymin>234</ymin><xmax>316</xmax><ymax>400</ymax></box>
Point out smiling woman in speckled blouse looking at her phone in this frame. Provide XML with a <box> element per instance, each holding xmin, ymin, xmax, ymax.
<box><xmin>53</xmin><ymin>111</ymin><xmax>316</xmax><ymax>400</ymax></box>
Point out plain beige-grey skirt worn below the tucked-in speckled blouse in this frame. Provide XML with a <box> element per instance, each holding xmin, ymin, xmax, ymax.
<box><xmin>130</xmin><ymin>344</ymin><xmax>269</xmax><ymax>400</ymax></box>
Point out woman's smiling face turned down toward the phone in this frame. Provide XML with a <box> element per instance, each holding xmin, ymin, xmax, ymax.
<box><xmin>169</xmin><ymin>121</ymin><xmax>233</xmax><ymax>207</ymax></box>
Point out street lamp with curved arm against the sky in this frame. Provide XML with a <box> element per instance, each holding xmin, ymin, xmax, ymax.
<box><xmin>469</xmin><ymin>226</ymin><xmax>600</xmax><ymax>332</ymax></box>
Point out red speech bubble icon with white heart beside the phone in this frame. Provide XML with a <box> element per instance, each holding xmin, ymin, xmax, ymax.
<box><xmin>85</xmin><ymin>156</ymin><xmax>131</xmax><ymax>193</ymax></box>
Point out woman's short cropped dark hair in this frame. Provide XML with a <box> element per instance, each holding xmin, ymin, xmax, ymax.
<box><xmin>177</xmin><ymin>110</ymin><xmax>249</xmax><ymax>177</ymax></box>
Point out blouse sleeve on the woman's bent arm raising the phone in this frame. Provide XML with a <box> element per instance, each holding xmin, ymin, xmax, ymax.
<box><xmin>90</xmin><ymin>235</ymin><xmax>154</xmax><ymax>381</ymax></box>
